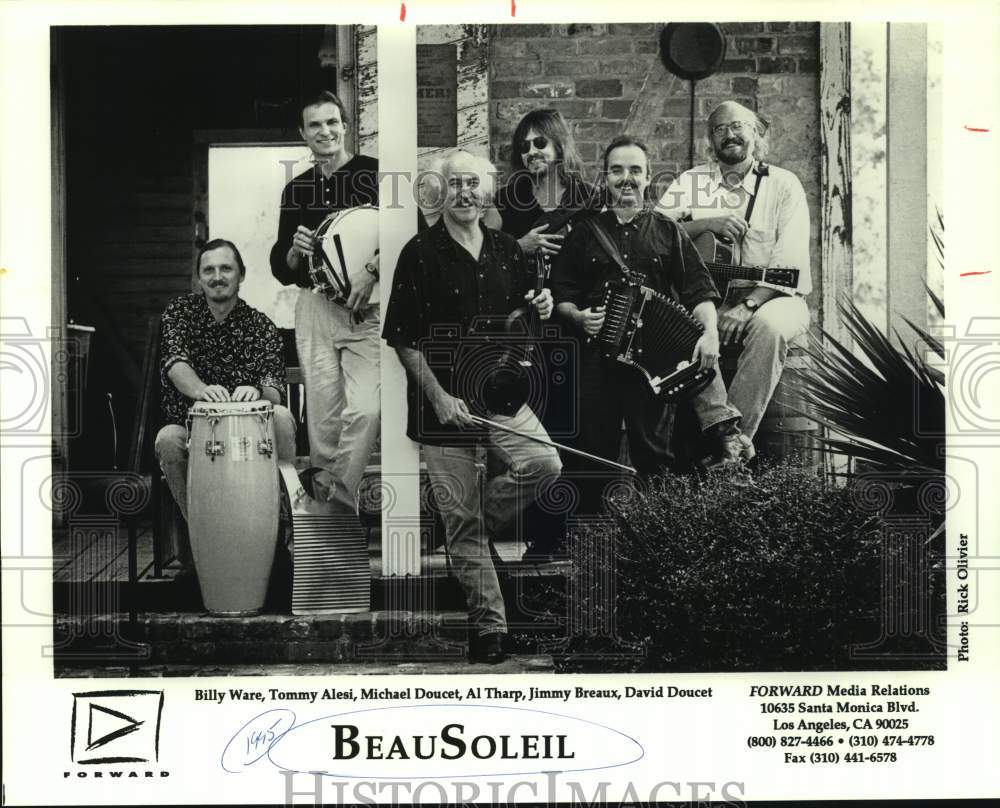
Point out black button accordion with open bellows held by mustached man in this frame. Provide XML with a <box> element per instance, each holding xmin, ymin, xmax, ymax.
<box><xmin>595</xmin><ymin>281</ymin><xmax>715</xmax><ymax>401</ymax></box>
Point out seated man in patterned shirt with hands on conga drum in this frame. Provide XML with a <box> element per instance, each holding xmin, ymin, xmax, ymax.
<box><xmin>156</xmin><ymin>239</ymin><xmax>295</xmax><ymax>519</ymax></box>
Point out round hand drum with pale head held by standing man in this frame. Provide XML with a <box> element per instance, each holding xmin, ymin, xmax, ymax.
<box><xmin>309</xmin><ymin>205</ymin><xmax>379</xmax><ymax>316</ymax></box>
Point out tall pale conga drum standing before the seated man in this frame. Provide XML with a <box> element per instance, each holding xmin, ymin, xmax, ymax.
<box><xmin>188</xmin><ymin>401</ymin><xmax>278</xmax><ymax>616</ymax></box>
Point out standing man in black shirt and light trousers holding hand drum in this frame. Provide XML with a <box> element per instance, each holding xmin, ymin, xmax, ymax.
<box><xmin>271</xmin><ymin>91</ymin><xmax>380</xmax><ymax>508</ymax></box>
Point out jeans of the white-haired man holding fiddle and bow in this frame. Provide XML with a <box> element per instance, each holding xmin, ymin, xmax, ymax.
<box><xmin>423</xmin><ymin>405</ymin><xmax>562</xmax><ymax>634</ymax></box>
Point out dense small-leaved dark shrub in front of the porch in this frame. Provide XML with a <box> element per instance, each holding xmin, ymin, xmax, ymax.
<box><xmin>561</xmin><ymin>465</ymin><xmax>944</xmax><ymax>671</ymax></box>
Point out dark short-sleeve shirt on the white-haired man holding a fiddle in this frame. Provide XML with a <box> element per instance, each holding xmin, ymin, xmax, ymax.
<box><xmin>382</xmin><ymin>217</ymin><xmax>535</xmax><ymax>444</ymax></box>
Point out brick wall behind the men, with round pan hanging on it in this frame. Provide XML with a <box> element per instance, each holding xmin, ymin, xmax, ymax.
<box><xmin>490</xmin><ymin>22</ymin><xmax>820</xmax><ymax>300</ymax></box>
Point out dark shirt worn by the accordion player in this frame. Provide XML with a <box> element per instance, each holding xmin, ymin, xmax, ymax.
<box><xmin>550</xmin><ymin>209</ymin><xmax>720</xmax><ymax>311</ymax></box>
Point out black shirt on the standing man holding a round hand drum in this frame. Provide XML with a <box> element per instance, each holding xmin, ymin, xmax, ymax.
<box><xmin>271</xmin><ymin>154</ymin><xmax>378</xmax><ymax>288</ymax></box>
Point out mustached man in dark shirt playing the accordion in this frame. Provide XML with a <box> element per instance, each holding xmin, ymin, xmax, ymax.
<box><xmin>552</xmin><ymin>135</ymin><xmax>745</xmax><ymax>502</ymax></box>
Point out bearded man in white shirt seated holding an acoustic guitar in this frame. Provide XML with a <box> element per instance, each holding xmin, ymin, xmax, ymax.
<box><xmin>657</xmin><ymin>101</ymin><xmax>812</xmax><ymax>459</ymax></box>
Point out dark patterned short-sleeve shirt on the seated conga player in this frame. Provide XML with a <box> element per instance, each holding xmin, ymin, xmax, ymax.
<box><xmin>160</xmin><ymin>292</ymin><xmax>285</xmax><ymax>424</ymax></box>
